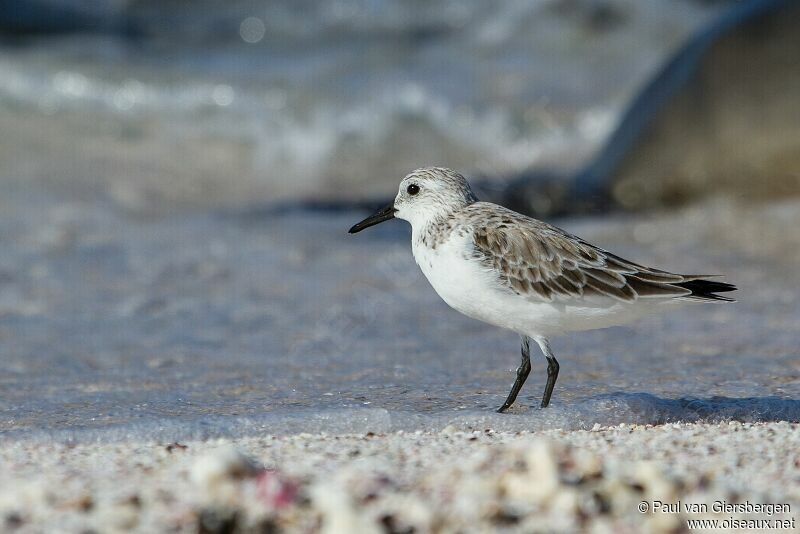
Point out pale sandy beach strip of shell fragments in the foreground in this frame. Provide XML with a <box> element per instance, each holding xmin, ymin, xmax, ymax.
<box><xmin>0</xmin><ymin>422</ymin><xmax>800</xmax><ymax>533</ymax></box>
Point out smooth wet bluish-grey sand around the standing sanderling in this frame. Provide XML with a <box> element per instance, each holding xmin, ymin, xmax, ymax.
<box><xmin>0</xmin><ymin>194</ymin><xmax>800</xmax><ymax>442</ymax></box>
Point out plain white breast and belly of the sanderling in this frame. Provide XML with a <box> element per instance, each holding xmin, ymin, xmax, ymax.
<box><xmin>413</xmin><ymin>236</ymin><xmax>664</xmax><ymax>336</ymax></box>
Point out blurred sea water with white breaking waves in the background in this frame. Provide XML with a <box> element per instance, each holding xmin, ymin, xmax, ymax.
<box><xmin>0</xmin><ymin>0</ymin><xmax>724</xmax><ymax>212</ymax></box>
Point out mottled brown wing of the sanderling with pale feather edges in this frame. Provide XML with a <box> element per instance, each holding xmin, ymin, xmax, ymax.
<box><xmin>473</xmin><ymin>216</ymin><xmax>693</xmax><ymax>302</ymax></box>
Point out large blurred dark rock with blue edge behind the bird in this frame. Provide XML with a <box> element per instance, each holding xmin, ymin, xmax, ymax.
<box><xmin>506</xmin><ymin>0</ymin><xmax>800</xmax><ymax>215</ymax></box>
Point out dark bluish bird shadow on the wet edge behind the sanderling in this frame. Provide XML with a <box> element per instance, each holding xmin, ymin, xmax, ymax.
<box><xmin>585</xmin><ymin>392</ymin><xmax>800</xmax><ymax>425</ymax></box>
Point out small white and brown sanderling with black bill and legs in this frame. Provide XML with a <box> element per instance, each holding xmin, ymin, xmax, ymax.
<box><xmin>350</xmin><ymin>167</ymin><xmax>736</xmax><ymax>412</ymax></box>
